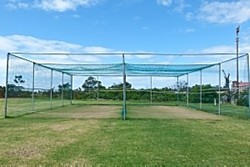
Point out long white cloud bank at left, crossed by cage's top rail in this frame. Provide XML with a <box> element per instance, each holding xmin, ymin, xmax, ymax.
<box><xmin>0</xmin><ymin>35</ymin><xmax>112</xmax><ymax>85</ymax></box>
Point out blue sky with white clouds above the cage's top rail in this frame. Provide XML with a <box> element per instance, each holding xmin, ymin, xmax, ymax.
<box><xmin>0</xmin><ymin>0</ymin><xmax>250</xmax><ymax>87</ymax></box>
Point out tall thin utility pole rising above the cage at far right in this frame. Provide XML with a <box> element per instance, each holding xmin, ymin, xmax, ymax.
<box><xmin>236</xmin><ymin>26</ymin><xmax>240</xmax><ymax>99</ymax></box>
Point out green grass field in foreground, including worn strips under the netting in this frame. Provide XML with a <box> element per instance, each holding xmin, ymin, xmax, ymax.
<box><xmin>0</xmin><ymin>101</ymin><xmax>250</xmax><ymax>166</ymax></box>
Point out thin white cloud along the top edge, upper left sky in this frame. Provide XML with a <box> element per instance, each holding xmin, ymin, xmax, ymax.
<box><xmin>7</xmin><ymin>0</ymin><xmax>101</xmax><ymax>12</ymax></box>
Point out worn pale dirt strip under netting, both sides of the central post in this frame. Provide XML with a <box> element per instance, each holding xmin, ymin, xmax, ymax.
<box><xmin>28</xmin><ymin>105</ymin><xmax>223</xmax><ymax>120</ymax></box>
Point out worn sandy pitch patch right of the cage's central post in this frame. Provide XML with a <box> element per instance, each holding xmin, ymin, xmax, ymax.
<box><xmin>129</xmin><ymin>106</ymin><xmax>222</xmax><ymax>120</ymax></box>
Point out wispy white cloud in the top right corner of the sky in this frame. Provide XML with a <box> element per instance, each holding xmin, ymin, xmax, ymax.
<box><xmin>198</xmin><ymin>0</ymin><xmax>250</xmax><ymax>24</ymax></box>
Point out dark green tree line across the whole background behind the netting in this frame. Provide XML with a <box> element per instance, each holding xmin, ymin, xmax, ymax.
<box><xmin>0</xmin><ymin>76</ymin><xmax>247</xmax><ymax>105</ymax></box>
